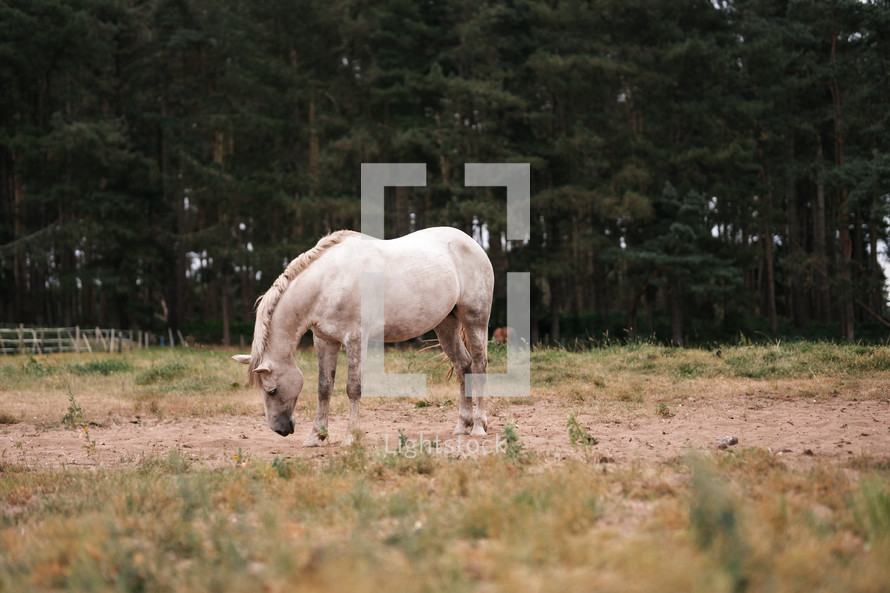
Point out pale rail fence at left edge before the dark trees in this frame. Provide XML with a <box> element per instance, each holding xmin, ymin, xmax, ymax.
<box><xmin>0</xmin><ymin>325</ymin><xmax>175</xmax><ymax>354</ymax></box>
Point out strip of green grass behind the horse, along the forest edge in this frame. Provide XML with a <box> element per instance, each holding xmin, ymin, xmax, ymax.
<box><xmin>0</xmin><ymin>342</ymin><xmax>890</xmax><ymax>393</ymax></box>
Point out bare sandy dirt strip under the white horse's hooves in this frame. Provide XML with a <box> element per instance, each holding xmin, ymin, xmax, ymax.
<box><xmin>0</xmin><ymin>390</ymin><xmax>890</xmax><ymax>469</ymax></box>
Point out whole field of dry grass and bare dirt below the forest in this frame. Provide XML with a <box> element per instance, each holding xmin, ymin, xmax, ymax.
<box><xmin>0</xmin><ymin>343</ymin><xmax>890</xmax><ymax>593</ymax></box>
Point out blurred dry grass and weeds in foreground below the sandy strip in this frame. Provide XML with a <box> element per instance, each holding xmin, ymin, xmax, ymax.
<box><xmin>0</xmin><ymin>443</ymin><xmax>890</xmax><ymax>592</ymax></box>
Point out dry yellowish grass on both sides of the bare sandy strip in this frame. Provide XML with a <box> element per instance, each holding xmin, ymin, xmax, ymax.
<box><xmin>0</xmin><ymin>345</ymin><xmax>890</xmax><ymax>593</ymax></box>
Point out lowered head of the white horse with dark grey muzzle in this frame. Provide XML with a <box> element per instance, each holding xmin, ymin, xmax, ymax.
<box><xmin>232</xmin><ymin>354</ymin><xmax>303</xmax><ymax>437</ymax></box>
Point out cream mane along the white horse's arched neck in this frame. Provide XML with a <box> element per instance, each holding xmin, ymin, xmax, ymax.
<box><xmin>247</xmin><ymin>231</ymin><xmax>359</xmax><ymax>385</ymax></box>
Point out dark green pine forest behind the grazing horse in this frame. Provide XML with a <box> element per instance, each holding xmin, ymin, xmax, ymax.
<box><xmin>0</xmin><ymin>0</ymin><xmax>890</xmax><ymax>345</ymax></box>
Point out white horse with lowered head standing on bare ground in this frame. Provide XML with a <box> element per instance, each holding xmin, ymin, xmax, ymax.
<box><xmin>232</xmin><ymin>227</ymin><xmax>494</xmax><ymax>447</ymax></box>
